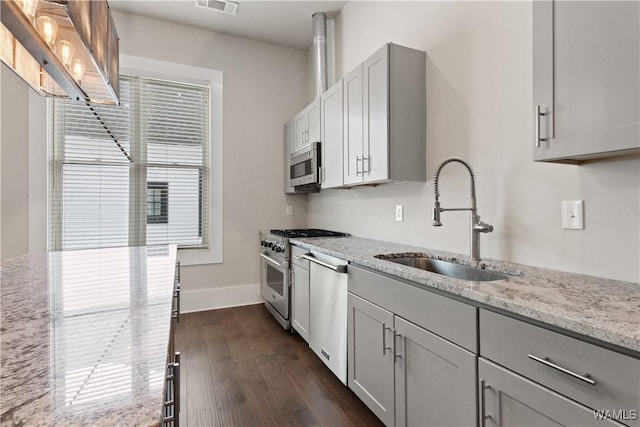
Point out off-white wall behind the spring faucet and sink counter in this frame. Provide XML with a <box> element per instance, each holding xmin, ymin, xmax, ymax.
<box><xmin>308</xmin><ymin>2</ymin><xmax>640</xmax><ymax>282</ymax></box>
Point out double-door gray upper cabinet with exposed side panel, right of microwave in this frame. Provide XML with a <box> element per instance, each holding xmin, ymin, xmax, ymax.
<box><xmin>344</xmin><ymin>43</ymin><xmax>426</xmax><ymax>185</ymax></box>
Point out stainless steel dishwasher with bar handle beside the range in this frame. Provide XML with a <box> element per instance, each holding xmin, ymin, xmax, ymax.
<box><xmin>303</xmin><ymin>252</ymin><xmax>347</xmax><ymax>384</ymax></box>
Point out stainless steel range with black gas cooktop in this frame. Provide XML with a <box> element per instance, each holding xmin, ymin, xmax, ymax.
<box><xmin>260</xmin><ymin>228</ymin><xmax>347</xmax><ymax>329</ymax></box>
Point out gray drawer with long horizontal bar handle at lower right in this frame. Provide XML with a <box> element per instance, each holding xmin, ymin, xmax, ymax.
<box><xmin>480</xmin><ymin>309</ymin><xmax>640</xmax><ymax>425</ymax></box>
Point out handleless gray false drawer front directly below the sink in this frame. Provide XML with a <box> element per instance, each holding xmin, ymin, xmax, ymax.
<box><xmin>348</xmin><ymin>265</ymin><xmax>477</xmax><ymax>353</ymax></box>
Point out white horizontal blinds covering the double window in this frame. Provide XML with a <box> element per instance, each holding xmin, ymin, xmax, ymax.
<box><xmin>49</xmin><ymin>75</ymin><xmax>210</xmax><ymax>250</ymax></box>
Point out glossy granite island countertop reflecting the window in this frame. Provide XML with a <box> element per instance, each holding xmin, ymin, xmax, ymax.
<box><xmin>0</xmin><ymin>246</ymin><xmax>176</xmax><ymax>426</ymax></box>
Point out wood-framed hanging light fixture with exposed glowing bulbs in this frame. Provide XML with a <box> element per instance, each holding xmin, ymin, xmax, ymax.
<box><xmin>0</xmin><ymin>0</ymin><xmax>120</xmax><ymax>105</ymax></box>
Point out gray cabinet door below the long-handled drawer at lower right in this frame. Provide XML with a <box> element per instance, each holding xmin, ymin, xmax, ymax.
<box><xmin>478</xmin><ymin>360</ymin><xmax>620</xmax><ymax>427</ymax></box>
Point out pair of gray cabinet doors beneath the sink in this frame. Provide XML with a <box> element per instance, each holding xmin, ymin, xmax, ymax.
<box><xmin>347</xmin><ymin>293</ymin><xmax>476</xmax><ymax>426</ymax></box>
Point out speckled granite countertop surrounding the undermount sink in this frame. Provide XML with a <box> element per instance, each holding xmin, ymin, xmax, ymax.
<box><xmin>291</xmin><ymin>237</ymin><xmax>640</xmax><ymax>357</ymax></box>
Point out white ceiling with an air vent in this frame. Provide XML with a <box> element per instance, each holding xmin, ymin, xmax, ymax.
<box><xmin>109</xmin><ymin>0</ymin><xmax>346</xmax><ymax>49</ymax></box>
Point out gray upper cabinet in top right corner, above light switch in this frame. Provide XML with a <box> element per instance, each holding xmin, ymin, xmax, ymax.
<box><xmin>533</xmin><ymin>1</ymin><xmax>640</xmax><ymax>163</ymax></box>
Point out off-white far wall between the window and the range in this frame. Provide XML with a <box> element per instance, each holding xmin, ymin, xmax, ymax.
<box><xmin>114</xmin><ymin>12</ymin><xmax>307</xmax><ymax>310</ymax></box>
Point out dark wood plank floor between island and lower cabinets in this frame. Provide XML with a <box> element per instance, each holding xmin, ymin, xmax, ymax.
<box><xmin>176</xmin><ymin>304</ymin><xmax>382</xmax><ymax>427</ymax></box>
